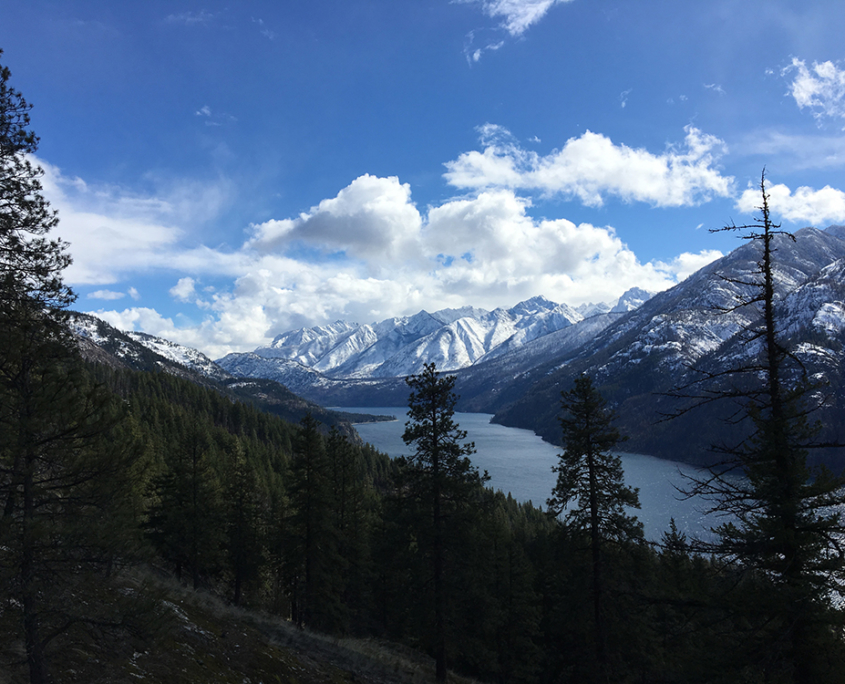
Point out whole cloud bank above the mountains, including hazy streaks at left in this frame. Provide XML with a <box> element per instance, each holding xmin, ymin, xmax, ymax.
<box><xmin>45</xmin><ymin>157</ymin><xmax>724</xmax><ymax>358</ymax></box>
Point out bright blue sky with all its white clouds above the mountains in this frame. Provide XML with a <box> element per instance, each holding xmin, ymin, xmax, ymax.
<box><xmin>0</xmin><ymin>0</ymin><xmax>845</xmax><ymax>358</ymax></box>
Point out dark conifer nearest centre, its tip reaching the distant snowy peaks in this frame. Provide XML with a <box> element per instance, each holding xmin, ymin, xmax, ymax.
<box><xmin>400</xmin><ymin>363</ymin><xmax>488</xmax><ymax>682</ymax></box>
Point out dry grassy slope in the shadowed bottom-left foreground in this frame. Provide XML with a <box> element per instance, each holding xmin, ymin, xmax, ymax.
<box><xmin>0</xmin><ymin>571</ymin><xmax>482</xmax><ymax>684</ymax></box>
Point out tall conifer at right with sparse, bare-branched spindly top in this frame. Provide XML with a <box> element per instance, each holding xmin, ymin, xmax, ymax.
<box><xmin>676</xmin><ymin>172</ymin><xmax>845</xmax><ymax>684</ymax></box>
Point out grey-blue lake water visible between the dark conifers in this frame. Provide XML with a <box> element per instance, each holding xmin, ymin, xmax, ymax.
<box><xmin>343</xmin><ymin>407</ymin><xmax>719</xmax><ymax>540</ymax></box>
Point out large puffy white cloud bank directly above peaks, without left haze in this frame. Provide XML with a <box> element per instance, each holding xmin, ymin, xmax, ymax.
<box><xmin>84</xmin><ymin>176</ymin><xmax>710</xmax><ymax>357</ymax></box>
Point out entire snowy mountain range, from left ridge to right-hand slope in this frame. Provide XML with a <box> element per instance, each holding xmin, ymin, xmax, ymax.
<box><xmin>72</xmin><ymin>226</ymin><xmax>845</xmax><ymax>467</ymax></box>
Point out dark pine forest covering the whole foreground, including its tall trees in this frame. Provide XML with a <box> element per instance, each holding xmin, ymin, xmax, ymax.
<box><xmin>0</xmin><ymin>49</ymin><xmax>845</xmax><ymax>684</ymax></box>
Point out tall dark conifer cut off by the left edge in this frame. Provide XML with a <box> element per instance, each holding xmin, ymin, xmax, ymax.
<box><xmin>0</xmin><ymin>53</ymin><xmax>145</xmax><ymax>684</ymax></box>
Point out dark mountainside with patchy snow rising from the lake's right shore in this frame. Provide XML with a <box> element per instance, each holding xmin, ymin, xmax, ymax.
<box><xmin>492</xmin><ymin>226</ymin><xmax>845</xmax><ymax>462</ymax></box>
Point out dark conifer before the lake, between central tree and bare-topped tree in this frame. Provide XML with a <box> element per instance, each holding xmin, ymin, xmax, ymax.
<box><xmin>547</xmin><ymin>375</ymin><xmax>642</xmax><ymax>678</ymax></box>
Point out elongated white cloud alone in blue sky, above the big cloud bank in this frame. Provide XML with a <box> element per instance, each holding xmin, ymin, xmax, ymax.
<box><xmin>444</xmin><ymin>124</ymin><xmax>733</xmax><ymax>207</ymax></box>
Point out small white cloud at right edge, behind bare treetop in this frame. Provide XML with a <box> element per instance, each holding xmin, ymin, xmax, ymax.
<box><xmin>736</xmin><ymin>184</ymin><xmax>845</xmax><ymax>228</ymax></box>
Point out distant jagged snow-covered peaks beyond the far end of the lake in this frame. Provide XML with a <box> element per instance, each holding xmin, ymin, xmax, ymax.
<box><xmin>217</xmin><ymin>288</ymin><xmax>649</xmax><ymax>380</ymax></box>
